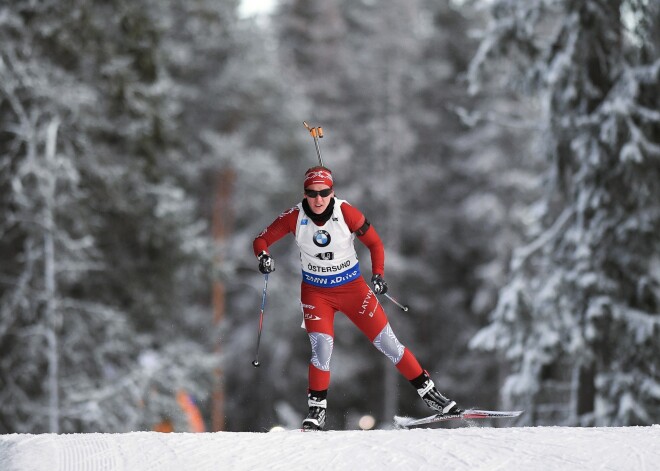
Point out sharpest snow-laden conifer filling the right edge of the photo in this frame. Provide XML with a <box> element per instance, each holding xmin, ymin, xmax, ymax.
<box><xmin>470</xmin><ymin>0</ymin><xmax>660</xmax><ymax>425</ymax></box>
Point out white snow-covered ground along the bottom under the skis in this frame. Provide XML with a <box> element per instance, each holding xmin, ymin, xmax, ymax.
<box><xmin>0</xmin><ymin>425</ymin><xmax>660</xmax><ymax>471</ymax></box>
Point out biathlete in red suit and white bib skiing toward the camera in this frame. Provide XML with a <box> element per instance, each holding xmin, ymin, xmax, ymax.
<box><xmin>253</xmin><ymin>166</ymin><xmax>461</xmax><ymax>430</ymax></box>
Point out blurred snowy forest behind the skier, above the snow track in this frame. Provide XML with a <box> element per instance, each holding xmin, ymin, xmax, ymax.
<box><xmin>0</xmin><ymin>0</ymin><xmax>660</xmax><ymax>433</ymax></box>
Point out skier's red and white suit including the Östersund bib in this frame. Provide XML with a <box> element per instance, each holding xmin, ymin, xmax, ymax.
<box><xmin>253</xmin><ymin>198</ymin><xmax>422</xmax><ymax>391</ymax></box>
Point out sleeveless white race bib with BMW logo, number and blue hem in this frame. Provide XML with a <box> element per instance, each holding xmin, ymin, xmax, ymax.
<box><xmin>296</xmin><ymin>198</ymin><xmax>360</xmax><ymax>288</ymax></box>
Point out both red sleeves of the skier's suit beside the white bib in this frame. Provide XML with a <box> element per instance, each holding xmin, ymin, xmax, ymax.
<box><xmin>252</xmin><ymin>203</ymin><xmax>385</xmax><ymax>275</ymax></box>
